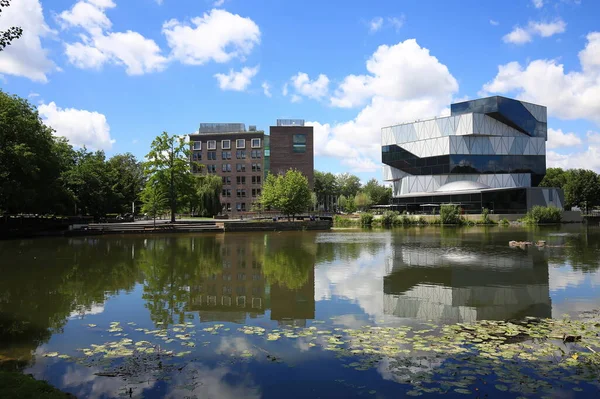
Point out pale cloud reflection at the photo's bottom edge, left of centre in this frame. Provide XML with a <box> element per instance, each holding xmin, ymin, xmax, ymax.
<box><xmin>164</xmin><ymin>363</ymin><xmax>262</xmax><ymax>399</ymax></box>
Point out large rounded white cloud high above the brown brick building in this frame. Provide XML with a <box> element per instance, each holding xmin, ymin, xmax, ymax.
<box><xmin>163</xmin><ymin>9</ymin><xmax>260</xmax><ymax>65</ymax></box>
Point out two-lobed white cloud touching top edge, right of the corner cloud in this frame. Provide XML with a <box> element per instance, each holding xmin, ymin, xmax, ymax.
<box><xmin>59</xmin><ymin>0</ymin><xmax>168</xmax><ymax>75</ymax></box>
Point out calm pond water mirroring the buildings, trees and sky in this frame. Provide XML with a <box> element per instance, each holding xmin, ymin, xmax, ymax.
<box><xmin>0</xmin><ymin>225</ymin><xmax>600</xmax><ymax>398</ymax></box>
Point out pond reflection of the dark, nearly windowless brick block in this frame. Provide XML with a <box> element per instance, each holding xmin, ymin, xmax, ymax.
<box><xmin>271</xmin><ymin>266</ymin><xmax>315</xmax><ymax>327</ymax></box>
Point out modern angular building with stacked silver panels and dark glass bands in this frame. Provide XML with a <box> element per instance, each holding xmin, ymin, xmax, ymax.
<box><xmin>381</xmin><ymin>96</ymin><xmax>563</xmax><ymax>213</ymax></box>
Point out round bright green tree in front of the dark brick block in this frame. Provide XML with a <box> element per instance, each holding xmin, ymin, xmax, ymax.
<box><xmin>260</xmin><ymin>169</ymin><xmax>311</xmax><ymax>220</ymax></box>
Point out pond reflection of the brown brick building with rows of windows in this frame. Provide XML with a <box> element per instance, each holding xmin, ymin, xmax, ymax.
<box><xmin>187</xmin><ymin>240</ymin><xmax>268</xmax><ymax>323</ymax></box>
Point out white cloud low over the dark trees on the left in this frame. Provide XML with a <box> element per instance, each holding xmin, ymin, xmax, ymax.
<box><xmin>38</xmin><ymin>102</ymin><xmax>115</xmax><ymax>150</ymax></box>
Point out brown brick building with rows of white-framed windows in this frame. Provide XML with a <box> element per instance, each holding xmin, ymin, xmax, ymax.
<box><xmin>189</xmin><ymin>123</ymin><xmax>268</xmax><ymax>215</ymax></box>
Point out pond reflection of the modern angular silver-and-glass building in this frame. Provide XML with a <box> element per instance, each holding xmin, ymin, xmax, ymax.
<box><xmin>383</xmin><ymin>247</ymin><xmax>551</xmax><ymax>322</ymax></box>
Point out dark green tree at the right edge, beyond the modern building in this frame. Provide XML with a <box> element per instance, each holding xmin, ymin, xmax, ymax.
<box><xmin>563</xmin><ymin>169</ymin><xmax>600</xmax><ymax>212</ymax></box>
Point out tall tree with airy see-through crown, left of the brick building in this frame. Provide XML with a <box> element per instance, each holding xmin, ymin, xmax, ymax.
<box><xmin>144</xmin><ymin>132</ymin><xmax>194</xmax><ymax>222</ymax></box>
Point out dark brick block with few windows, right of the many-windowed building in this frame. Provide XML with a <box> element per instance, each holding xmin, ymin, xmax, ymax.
<box><xmin>269</xmin><ymin>119</ymin><xmax>315</xmax><ymax>188</ymax></box>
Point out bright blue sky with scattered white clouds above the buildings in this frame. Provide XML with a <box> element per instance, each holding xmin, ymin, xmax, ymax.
<box><xmin>0</xmin><ymin>0</ymin><xmax>600</xmax><ymax>181</ymax></box>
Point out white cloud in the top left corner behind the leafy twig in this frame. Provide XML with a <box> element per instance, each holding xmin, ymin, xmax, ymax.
<box><xmin>0</xmin><ymin>0</ymin><xmax>55</xmax><ymax>82</ymax></box>
